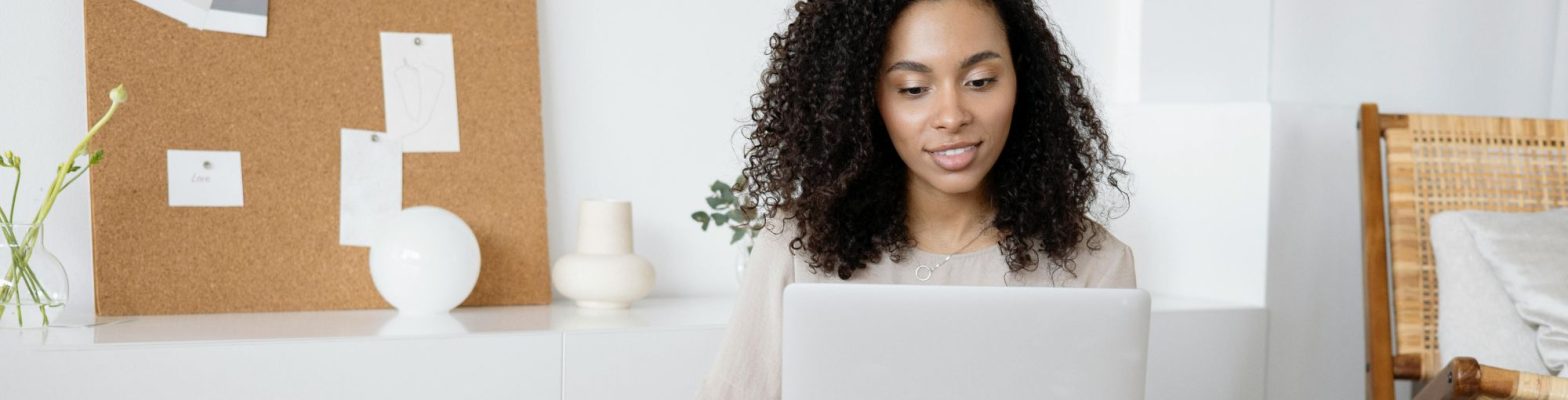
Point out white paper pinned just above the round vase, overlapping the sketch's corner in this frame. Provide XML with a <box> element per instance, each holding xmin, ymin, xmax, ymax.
<box><xmin>337</xmin><ymin>129</ymin><xmax>403</xmax><ymax>246</ymax></box>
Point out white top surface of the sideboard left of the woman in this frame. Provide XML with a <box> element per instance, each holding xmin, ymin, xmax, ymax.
<box><xmin>0</xmin><ymin>296</ymin><xmax>734</xmax><ymax>350</ymax></box>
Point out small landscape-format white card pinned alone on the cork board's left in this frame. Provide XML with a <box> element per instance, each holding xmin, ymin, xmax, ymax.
<box><xmin>169</xmin><ymin>151</ymin><xmax>245</xmax><ymax>207</ymax></box>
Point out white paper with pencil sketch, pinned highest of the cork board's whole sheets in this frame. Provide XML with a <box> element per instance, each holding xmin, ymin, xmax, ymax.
<box><xmin>381</xmin><ymin>31</ymin><xmax>458</xmax><ymax>152</ymax></box>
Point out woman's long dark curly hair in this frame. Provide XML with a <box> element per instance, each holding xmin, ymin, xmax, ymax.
<box><xmin>743</xmin><ymin>0</ymin><xmax>1127</xmax><ymax>279</ymax></box>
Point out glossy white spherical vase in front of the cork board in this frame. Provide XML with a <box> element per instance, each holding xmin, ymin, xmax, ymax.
<box><xmin>370</xmin><ymin>205</ymin><xmax>480</xmax><ymax>314</ymax></box>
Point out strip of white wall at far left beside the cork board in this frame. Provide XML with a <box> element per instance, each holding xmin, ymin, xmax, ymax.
<box><xmin>0</xmin><ymin>0</ymin><xmax>92</xmax><ymax>323</ymax></box>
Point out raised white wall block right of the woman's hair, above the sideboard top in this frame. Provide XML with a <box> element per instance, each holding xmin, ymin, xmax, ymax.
<box><xmin>1105</xmin><ymin>102</ymin><xmax>1270</xmax><ymax>306</ymax></box>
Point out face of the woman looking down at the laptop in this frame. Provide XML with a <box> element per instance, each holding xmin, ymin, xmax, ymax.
<box><xmin>877</xmin><ymin>0</ymin><xmax>1018</xmax><ymax>195</ymax></box>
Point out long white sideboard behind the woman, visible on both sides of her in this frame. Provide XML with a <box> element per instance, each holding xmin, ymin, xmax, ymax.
<box><xmin>0</xmin><ymin>295</ymin><xmax>1267</xmax><ymax>400</ymax></box>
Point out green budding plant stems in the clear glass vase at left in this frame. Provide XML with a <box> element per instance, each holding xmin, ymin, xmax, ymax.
<box><xmin>0</xmin><ymin>85</ymin><xmax>129</xmax><ymax>326</ymax></box>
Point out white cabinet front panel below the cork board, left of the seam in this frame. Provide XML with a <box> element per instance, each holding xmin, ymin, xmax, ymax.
<box><xmin>0</xmin><ymin>334</ymin><xmax>561</xmax><ymax>398</ymax></box>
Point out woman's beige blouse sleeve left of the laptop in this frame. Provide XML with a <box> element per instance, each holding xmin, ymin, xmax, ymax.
<box><xmin>698</xmin><ymin>223</ymin><xmax>795</xmax><ymax>400</ymax></box>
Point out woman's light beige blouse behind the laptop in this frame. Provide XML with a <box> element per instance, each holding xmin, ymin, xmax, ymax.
<box><xmin>698</xmin><ymin>220</ymin><xmax>1137</xmax><ymax>400</ymax></box>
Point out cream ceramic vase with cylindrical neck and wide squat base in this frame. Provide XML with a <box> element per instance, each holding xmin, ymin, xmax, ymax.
<box><xmin>550</xmin><ymin>199</ymin><xmax>654</xmax><ymax>309</ymax></box>
